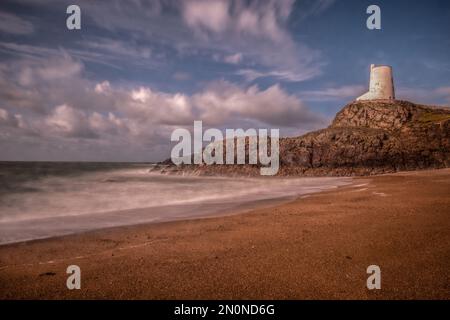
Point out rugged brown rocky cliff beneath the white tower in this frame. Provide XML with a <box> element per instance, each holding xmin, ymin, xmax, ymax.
<box><xmin>156</xmin><ymin>101</ymin><xmax>450</xmax><ymax>176</ymax></box>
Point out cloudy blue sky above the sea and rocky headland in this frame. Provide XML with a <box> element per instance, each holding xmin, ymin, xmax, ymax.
<box><xmin>0</xmin><ymin>0</ymin><xmax>450</xmax><ymax>162</ymax></box>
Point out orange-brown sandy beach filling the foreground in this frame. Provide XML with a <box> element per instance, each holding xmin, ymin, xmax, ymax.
<box><xmin>0</xmin><ymin>169</ymin><xmax>450</xmax><ymax>299</ymax></box>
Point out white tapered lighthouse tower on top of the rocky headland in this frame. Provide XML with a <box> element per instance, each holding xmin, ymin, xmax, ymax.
<box><xmin>356</xmin><ymin>64</ymin><xmax>395</xmax><ymax>101</ymax></box>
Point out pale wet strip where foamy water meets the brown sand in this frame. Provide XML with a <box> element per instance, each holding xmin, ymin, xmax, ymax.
<box><xmin>0</xmin><ymin>175</ymin><xmax>353</xmax><ymax>246</ymax></box>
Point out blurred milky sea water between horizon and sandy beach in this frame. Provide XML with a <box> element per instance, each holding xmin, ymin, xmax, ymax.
<box><xmin>0</xmin><ymin>162</ymin><xmax>351</xmax><ymax>244</ymax></box>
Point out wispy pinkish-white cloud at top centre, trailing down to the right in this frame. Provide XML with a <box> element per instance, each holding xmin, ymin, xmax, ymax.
<box><xmin>178</xmin><ymin>0</ymin><xmax>324</xmax><ymax>81</ymax></box>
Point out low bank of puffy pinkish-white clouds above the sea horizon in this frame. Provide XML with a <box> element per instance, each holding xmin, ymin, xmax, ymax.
<box><xmin>0</xmin><ymin>52</ymin><xmax>325</xmax><ymax>160</ymax></box>
